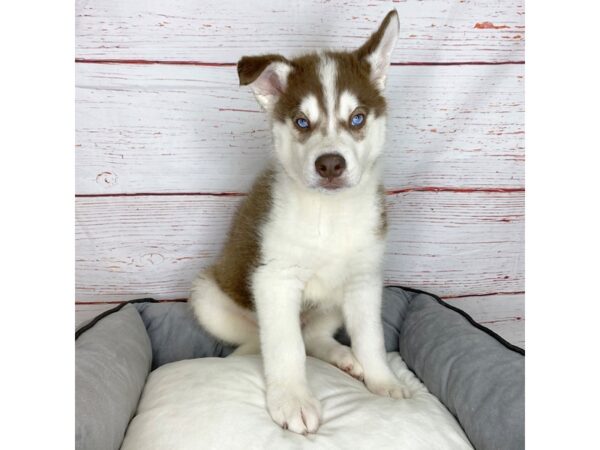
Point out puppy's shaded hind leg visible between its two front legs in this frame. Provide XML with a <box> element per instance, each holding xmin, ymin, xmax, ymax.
<box><xmin>302</xmin><ymin>307</ymin><xmax>363</xmax><ymax>380</ymax></box>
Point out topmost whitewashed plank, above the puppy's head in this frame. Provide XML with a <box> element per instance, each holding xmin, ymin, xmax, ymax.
<box><xmin>76</xmin><ymin>0</ymin><xmax>525</xmax><ymax>62</ymax></box>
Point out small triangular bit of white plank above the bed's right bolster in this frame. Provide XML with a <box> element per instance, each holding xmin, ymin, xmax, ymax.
<box><xmin>446</xmin><ymin>294</ymin><xmax>525</xmax><ymax>347</ymax></box>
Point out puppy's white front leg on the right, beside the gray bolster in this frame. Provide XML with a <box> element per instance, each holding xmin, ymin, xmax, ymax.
<box><xmin>343</xmin><ymin>274</ymin><xmax>410</xmax><ymax>398</ymax></box>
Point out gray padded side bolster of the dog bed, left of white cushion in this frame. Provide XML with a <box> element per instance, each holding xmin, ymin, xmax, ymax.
<box><xmin>75</xmin><ymin>305</ymin><xmax>152</xmax><ymax>450</ymax></box>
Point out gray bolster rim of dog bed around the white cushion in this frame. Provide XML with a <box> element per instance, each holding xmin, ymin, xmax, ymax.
<box><xmin>75</xmin><ymin>287</ymin><xmax>525</xmax><ymax>450</ymax></box>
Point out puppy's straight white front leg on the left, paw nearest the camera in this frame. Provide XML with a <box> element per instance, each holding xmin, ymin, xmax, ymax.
<box><xmin>252</xmin><ymin>267</ymin><xmax>321</xmax><ymax>434</ymax></box>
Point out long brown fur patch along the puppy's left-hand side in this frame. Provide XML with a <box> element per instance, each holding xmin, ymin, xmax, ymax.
<box><xmin>212</xmin><ymin>168</ymin><xmax>275</xmax><ymax>309</ymax></box>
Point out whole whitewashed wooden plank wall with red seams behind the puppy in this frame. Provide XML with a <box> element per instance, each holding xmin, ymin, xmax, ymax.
<box><xmin>75</xmin><ymin>0</ymin><xmax>525</xmax><ymax>345</ymax></box>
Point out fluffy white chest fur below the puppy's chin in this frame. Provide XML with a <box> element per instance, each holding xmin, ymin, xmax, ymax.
<box><xmin>261</xmin><ymin>169</ymin><xmax>384</xmax><ymax>303</ymax></box>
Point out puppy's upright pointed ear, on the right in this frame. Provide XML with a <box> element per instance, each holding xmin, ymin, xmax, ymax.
<box><xmin>356</xmin><ymin>9</ymin><xmax>400</xmax><ymax>91</ymax></box>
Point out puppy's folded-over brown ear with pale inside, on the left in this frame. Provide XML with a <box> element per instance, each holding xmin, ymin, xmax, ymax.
<box><xmin>238</xmin><ymin>55</ymin><xmax>292</xmax><ymax>112</ymax></box>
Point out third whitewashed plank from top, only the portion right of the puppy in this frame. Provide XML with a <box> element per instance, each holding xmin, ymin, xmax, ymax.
<box><xmin>385</xmin><ymin>192</ymin><xmax>524</xmax><ymax>296</ymax></box>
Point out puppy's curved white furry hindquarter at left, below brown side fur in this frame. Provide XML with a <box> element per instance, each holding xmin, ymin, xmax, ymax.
<box><xmin>188</xmin><ymin>270</ymin><xmax>260</xmax><ymax>354</ymax></box>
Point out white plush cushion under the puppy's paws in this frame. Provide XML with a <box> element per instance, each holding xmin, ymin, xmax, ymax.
<box><xmin>121</xmin><ymin>353</ymin><xmax>472</xmax><ymax>450</ymax></box>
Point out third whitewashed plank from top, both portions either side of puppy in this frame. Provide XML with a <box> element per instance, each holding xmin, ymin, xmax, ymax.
<box><xmin>76</xmin><ymin>191</ymin><xmax>524</xmax><ymax>302</ymax></box>
